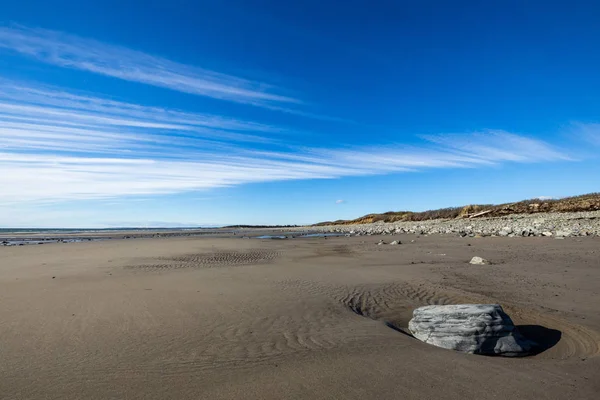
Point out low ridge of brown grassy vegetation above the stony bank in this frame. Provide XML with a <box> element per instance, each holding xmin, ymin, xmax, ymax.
<box><xmin>315</xmin><ymin>193</ymin><xmax>600</xmax><ymax>226</ymax></box>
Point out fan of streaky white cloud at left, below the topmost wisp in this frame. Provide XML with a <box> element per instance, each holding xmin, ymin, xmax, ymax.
<box><xmin>0</xmin><ymin>79</ymin><xmax>286</xmax><ymax>157</ymax></box>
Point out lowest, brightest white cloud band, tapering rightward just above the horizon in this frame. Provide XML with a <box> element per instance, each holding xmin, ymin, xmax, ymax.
<box><xmin>0</xmin><ymin>135</ymin><xmax>560</xmax><ymax>202</ymax></box>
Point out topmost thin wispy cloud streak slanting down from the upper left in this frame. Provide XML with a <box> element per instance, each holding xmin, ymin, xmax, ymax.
<box><xmin>0</xmin><ymin>25</ymin><xmax>301</xmax><ymax>107</ymax></box>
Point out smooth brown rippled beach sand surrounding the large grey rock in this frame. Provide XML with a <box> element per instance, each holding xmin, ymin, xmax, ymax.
<box><xmin>0</xmin><ymin>235</ymin><xmax>600</xmax><ymax>399</ymax></box>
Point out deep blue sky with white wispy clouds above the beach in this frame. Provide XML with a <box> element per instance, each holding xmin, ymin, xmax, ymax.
<box><xmin>0</xmin><ymin>0</ymin><xmax>600</xmax><ymax>227</ymax></box>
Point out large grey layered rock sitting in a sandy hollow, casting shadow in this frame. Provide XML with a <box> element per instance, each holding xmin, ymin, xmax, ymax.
<box><xmin>408</xmin><ymin>304</ymin><xmax>535</xmax><ymax>357</ymax></box>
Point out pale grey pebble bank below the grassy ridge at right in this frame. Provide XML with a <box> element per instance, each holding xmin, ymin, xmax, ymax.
<box><xmin>302</xmin><ymin>211</ymin><xmax>600</xmax><ymax>237</ymax></box>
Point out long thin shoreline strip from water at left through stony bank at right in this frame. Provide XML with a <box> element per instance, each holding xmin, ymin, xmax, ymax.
<box><xmin>0</xmin><ymin>211</ymin><xmax>600</xmax><ymax>246</ymax></box>
